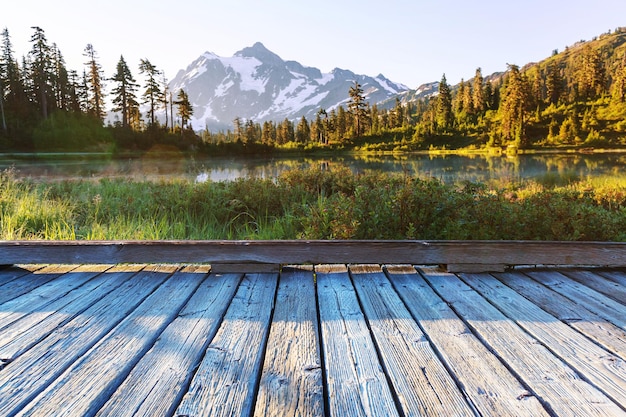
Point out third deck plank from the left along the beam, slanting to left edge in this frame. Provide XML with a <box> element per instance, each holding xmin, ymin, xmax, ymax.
<box><xmin>0</xmin><ymin>265</ymin><xmax>111</xmax><ymax>334</ymax></box>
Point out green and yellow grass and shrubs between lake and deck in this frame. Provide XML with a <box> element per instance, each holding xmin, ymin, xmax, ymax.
<box><xmin>0</xmin><ymin>169</ymin><xmax>626</xmax><ymax>241</ymax></box>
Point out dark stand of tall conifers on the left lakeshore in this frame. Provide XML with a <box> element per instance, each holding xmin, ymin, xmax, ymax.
<box><xmin>0</xmin><ymin>26</ymin><xmax>193</xmax><ymax>149</ymax></box>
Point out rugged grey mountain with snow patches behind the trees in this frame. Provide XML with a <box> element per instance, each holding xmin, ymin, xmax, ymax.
<box><xmin>169</xmin><ymin>43</ymin><xmax>409</xmax><ymax>130</ymax></box>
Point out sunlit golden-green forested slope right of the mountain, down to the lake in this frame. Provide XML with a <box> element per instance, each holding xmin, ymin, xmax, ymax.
<box><xmin>211</xmin><ymin>28</ymin><xmax>626</xmax><ymax>150</ymax></box>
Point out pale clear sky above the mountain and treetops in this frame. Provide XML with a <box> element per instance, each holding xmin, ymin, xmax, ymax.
<box><xmin>0</xmin><ymin>0</ymin><xmax>626</xmax><ymax>88</ymax></box>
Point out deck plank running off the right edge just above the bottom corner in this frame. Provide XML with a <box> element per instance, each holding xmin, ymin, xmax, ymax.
<box><xmin>461</xmin><ymin>274</ymin><xmax>626</xmax><ymax>404</ymax></box>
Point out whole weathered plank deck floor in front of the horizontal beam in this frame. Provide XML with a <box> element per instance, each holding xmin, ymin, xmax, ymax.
<box><xmin>0</xmin><ymin>264</ymin><xmax>626</xmax><ymax>417</ymax></box>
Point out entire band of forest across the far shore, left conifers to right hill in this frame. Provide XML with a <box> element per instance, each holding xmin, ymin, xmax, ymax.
<box><xmin>0</xmin><ymin>27</ymin><xmax>626</xmax><ymax>152</ymax></box>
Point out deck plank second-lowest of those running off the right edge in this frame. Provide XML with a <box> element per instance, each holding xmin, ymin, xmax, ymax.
<box><xmin>495</xmin><ymin>272</ymin><xmax>626</xmax><ymax>359</ymax></box>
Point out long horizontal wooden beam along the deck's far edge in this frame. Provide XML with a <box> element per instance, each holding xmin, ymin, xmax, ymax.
<box><xmin>0</xmin><ymin>240</ymin><xmax>626</xmax><ymax>267</ymax></box>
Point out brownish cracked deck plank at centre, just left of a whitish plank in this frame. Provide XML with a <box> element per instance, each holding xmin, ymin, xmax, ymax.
<box><xmin>254</xmin><ymin>267</ymin><xmax>324</xmax><ymax>417</ymax></box>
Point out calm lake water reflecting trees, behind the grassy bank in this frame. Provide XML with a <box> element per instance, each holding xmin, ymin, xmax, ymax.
<box><xmin>0</xmin><ymin>152</ymin><xmax>626</xmax><ymax>183</ymax></box>
